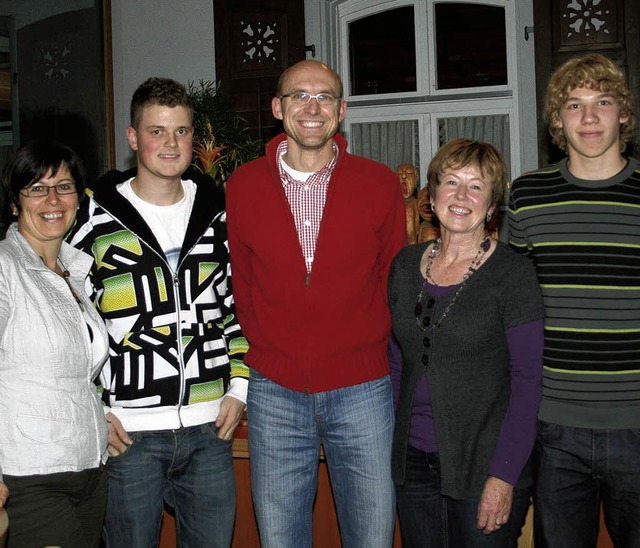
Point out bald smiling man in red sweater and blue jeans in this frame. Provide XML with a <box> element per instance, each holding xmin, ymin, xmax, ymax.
<box><xmin>227</xmin><ymin>60</ymin><xmax>406</xmax><ymax>548</ymax></box>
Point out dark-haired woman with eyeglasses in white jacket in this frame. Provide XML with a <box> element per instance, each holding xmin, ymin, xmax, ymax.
<box><xmin>0</xmin><ymin>141</ymin><xmax>108</xmax><ymax>548</ymax></box>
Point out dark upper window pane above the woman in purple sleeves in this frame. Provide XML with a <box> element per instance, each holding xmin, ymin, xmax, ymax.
<box><xmin>435</xmin><ymin>2</ymin><xmax>507</xmax><ymax>89</ymax></box>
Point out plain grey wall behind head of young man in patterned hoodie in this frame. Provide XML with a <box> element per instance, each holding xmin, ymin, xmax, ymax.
<box><xmin>111</xmin><ymin>0</ymin><xmax>215</xmax><ymax>169</ymax></box>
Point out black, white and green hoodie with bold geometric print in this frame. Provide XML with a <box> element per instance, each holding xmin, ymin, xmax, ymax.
<box><xmin>68</xmin><ymin>170</ymin><xmax>248</xmax><ymax>432</ymax></box>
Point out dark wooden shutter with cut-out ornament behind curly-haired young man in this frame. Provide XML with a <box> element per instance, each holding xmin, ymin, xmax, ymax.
<box><xmin>533</xmin><ymin>0</ymin><xmax>640</xmax><ymax>165</ymax></box>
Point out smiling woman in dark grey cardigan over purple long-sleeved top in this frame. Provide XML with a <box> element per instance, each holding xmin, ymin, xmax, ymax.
<box><xmin>389</xmin><ymin>139</ymin><xmax>543</xmax><ymax>548</ymax></box>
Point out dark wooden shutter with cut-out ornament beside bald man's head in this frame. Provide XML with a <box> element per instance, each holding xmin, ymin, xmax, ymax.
<box><xmin>213</xmin><ymin>0</ymin><xmax>305</xmax><ymax>139</ymax></box>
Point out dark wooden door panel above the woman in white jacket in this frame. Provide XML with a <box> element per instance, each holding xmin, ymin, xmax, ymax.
<box><xmin>15</xmin><ymin>0</ymin><xmax>115</xmax><ymax>185</ymax></box>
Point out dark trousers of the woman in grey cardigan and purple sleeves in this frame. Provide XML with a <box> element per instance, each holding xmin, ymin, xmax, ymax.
<box><xmin>396</xmin><ymin>446</ymin><xmax>531</xmax><ymax>548</ymax></box>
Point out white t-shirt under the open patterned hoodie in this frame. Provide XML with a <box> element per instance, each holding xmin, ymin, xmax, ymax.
<box><xmin>117</xmin><ymin>178</ymin><xmax>196</xmax><ymax>272</ymax></box>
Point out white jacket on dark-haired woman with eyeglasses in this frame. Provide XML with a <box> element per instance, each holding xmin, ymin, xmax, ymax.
<box><xmin>0</xmin><ymin>223</ymin><xmax>108</xmax><ymax>476</ymax></box>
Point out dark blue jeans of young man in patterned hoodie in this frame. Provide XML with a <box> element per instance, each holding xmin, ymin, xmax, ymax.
<box><xmin>104</xmin><ymin>423</ymin><xmax>236</xmax><ymax>548</ymax></box>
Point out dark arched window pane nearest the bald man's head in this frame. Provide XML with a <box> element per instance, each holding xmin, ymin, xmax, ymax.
<box><xmin>349</xmin><ymin>6</ymin><xmax>416</xmax><ymax>95</ymax></box>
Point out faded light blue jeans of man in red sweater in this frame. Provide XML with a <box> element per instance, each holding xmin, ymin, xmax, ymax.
<box><xmin>247</xmin><ymin>370</ymin><xmax>395</xmax><ymax>548</ymax></box>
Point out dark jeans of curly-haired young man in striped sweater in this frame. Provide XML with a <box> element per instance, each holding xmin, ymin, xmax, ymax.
<box><xmin>534</xmin><ymin>421</ymin><xmax>640</xmax><ymax>548</ymax></box>
